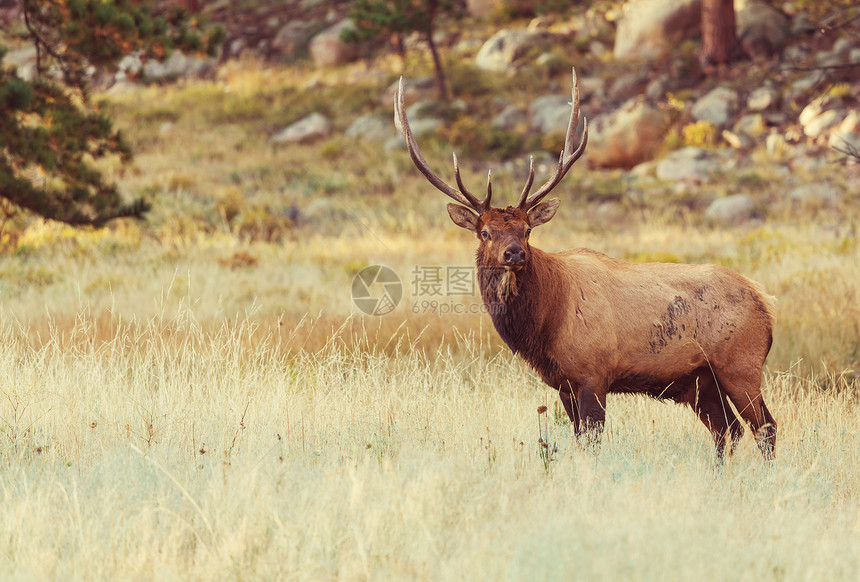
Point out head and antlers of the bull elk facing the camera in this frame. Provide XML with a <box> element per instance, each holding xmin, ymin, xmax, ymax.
<box><xmin>394</xmin><ymin>69</ymin><xmax>588</xmax><ymax>301</ymax></box>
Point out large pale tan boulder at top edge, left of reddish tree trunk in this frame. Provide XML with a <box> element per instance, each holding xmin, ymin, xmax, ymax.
<box><xmin>613</xmin><ymin>0</ymin><xmax>702</xmax><ymax>61</ymax></box>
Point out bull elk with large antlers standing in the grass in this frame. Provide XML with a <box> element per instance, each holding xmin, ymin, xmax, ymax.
<box><xmin>394</xmin><ymin>70</ymin><xmax>776</xmax><ymax>459</ymax></box>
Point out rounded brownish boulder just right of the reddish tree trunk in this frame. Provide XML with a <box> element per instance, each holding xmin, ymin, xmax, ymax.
<box><xmin>735</xmin><ymin>0</ymin><xmax>789</xmax><ymax>58</ymax></box>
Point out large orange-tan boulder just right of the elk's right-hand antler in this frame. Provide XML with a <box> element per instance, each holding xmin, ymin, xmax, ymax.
<box><xmin>585</xmin><ymin>99</ymin><xmax>670</xmax><ymax>168</ymax></box>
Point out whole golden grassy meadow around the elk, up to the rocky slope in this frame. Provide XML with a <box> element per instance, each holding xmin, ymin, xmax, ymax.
<box><xmin>0</xmin><ymin>58</ymin><xmax>860</xmax><ymax>580</ymax></box>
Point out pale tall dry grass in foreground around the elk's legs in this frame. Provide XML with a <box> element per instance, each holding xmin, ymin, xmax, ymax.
<box><xmin>0</xmin><ymin>310</ymin><xmax>860</xmax><ymax>580</ymax></box>
